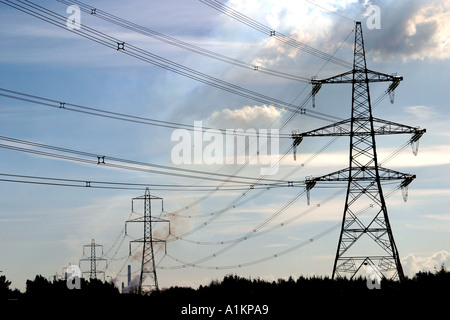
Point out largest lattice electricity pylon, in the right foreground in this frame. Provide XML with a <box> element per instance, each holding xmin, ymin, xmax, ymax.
<box><xmin>292</xmin><ymin>22</ymin><xmax>426</xmax><ymax>281</ymax></box>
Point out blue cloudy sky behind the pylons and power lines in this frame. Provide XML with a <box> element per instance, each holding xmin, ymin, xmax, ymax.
<box><xmin>0</xmin><ymin>0</ymin><xmax>450</xmax><ymax>291</ymax></box>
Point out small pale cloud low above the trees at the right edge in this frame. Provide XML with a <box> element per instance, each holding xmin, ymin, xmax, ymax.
<box><xmin>402</xmin><ymin>250</ymin><xmax>450</xmax><ymax>276</ymax></box>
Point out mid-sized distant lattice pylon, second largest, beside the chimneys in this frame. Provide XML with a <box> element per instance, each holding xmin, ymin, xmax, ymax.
<box><xmin>125</xmin><ymin>188</ymin><xmax>170</xmax><ymax>294</ymax></box>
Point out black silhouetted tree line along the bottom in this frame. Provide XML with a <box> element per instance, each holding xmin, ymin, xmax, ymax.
<box><xmin>0</xmin><ymin>266</ymin><xmax>450</xmax><ymax>319</ymax></box>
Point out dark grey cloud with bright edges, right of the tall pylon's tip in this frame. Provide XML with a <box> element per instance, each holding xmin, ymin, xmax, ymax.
<box><xmin>366</xmin><ymin>0</ymin><xmax>450</xmax><ymax>61</ymax></box>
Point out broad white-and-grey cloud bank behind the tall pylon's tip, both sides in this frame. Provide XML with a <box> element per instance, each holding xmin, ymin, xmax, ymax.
<box><xmin>234</xmin><ymin>0</ymin><xmax>450</xmax><ymax>61</ymax></box>
